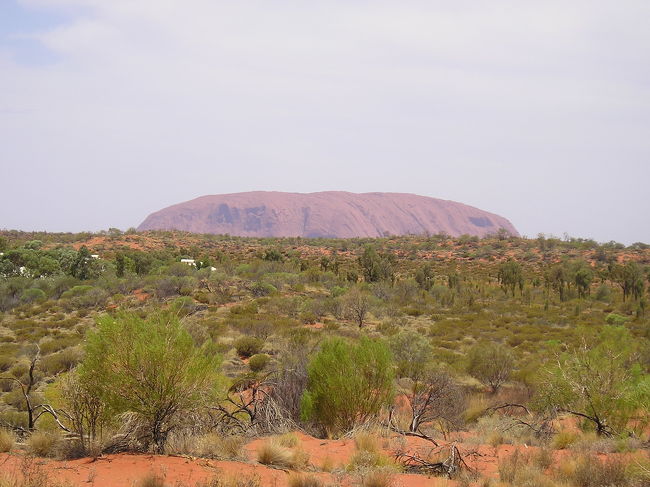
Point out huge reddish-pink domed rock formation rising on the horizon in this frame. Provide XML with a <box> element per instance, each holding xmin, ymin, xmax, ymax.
<box><xmin>138</xmin><ymin>191</ymin><xmax>518</xmax><ymax>238</ymax></box>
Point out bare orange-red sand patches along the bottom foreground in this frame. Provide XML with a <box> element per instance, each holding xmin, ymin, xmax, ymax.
<box><xmin>0</xmin><ymin>433</ymin><xmax>644</xmax><ymax>487</ymax></box>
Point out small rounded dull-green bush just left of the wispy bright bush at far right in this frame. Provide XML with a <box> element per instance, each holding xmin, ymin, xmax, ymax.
<box><xmin>467</xmin><ymin>342</ymin><xmax>514</xmax><ymax>394</ymax></box>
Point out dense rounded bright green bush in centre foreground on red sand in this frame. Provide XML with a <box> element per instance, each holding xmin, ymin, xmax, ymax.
<box><xmin>301</xmin><ymin>337</ymin><xmax>393</xmax><ymax>434</ymax></box>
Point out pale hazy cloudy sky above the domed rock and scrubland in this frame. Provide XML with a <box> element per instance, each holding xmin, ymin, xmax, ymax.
<box><xmin>0</xmin><ymin>0</ymin><xmax>650</xmax><ymax>244</ymax></box>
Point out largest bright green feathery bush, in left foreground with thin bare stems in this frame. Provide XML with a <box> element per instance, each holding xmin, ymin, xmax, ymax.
<box><xmin>80</xmin><ymin>313</ymin><xmax>219</xmax><ymax>453</ymax></box>
